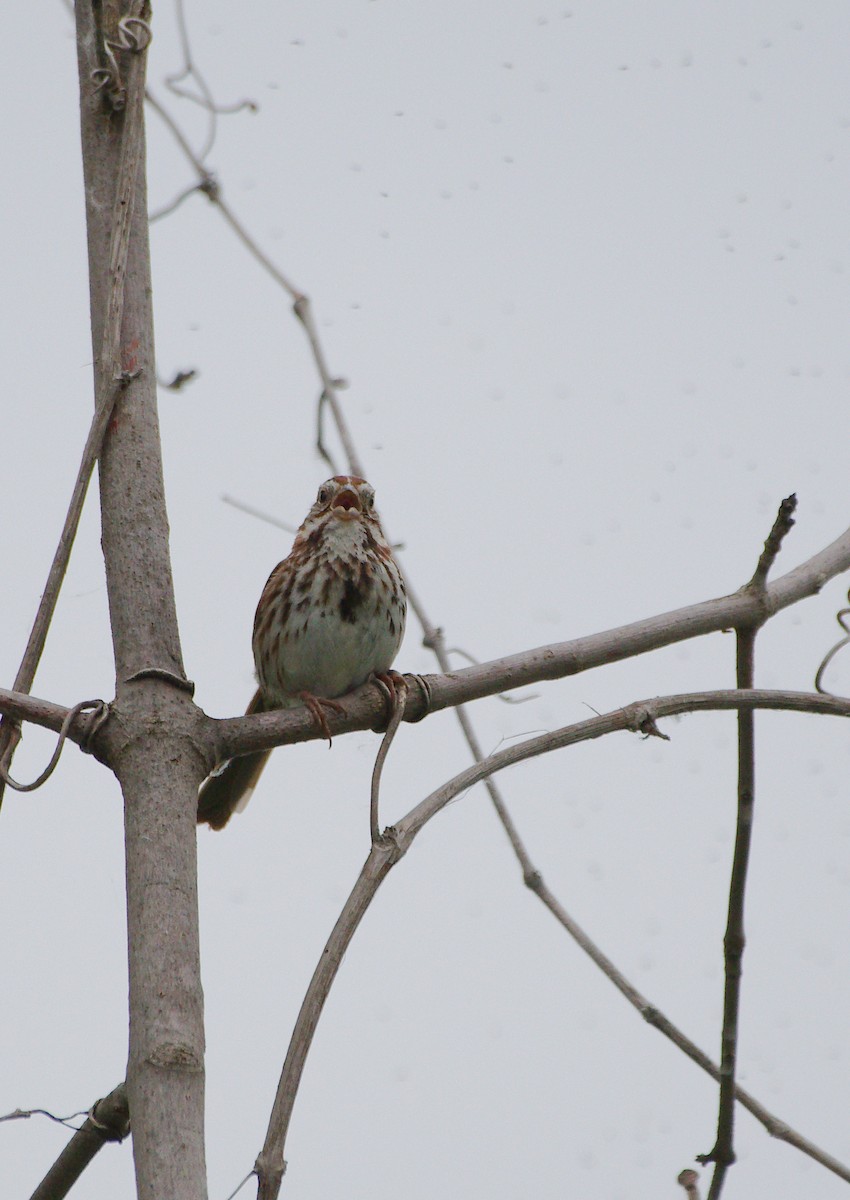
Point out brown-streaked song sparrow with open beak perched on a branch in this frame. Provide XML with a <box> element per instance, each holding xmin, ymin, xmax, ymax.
<box><xmin>198</xmin><ymin>475</ymin><xmax>407</xmax><ymax>829</ymax></box>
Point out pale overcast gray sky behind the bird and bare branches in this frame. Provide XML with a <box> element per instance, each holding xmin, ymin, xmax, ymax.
<box><xmin>0</xmin><ymin>0</ymin><xmax>850</xmax><ymax>1200</ymax></box>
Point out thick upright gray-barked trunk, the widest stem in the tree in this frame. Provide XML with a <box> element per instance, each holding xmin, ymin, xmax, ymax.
<box><xmin>76</xmin><ymin>0</ymin><xmax>206</xmax><ymax>1200</ymax></box>
